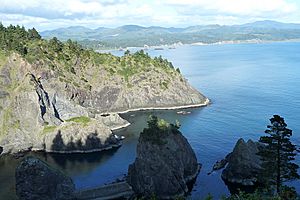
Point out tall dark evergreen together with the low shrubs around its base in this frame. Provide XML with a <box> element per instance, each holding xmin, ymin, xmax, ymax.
<box><xmin>224</xmin><ymin>115</ymin><xmax>300</xmax><ymax>200</ymax></box>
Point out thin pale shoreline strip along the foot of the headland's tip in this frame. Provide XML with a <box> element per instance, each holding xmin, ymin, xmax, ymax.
<box><xmin>113</xmin><ymin>98</ymin><xmax>211</xmax><ymax>114</ymax></box>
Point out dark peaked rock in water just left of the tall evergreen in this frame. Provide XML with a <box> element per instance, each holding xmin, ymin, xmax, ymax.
<box><xmin>222</xmin><ymin>139</ymin><xmax>261</xmax><ymax>186</ymax></box>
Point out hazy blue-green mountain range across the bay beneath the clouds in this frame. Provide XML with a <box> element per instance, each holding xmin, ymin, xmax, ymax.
<box><xmin>40</xmin><ymin>20</ymin><xmax>300</xmax><ymax>49</ymax></box>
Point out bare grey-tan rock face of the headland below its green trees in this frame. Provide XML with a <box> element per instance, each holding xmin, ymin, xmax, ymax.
<box><xmin>0</xmin><ymin>49</ymin><xmax>208</xmax><ymax>153</ymax></box>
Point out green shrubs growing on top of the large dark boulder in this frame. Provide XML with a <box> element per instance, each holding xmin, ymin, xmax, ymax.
<box><xmin>141</xmin><ymin>115</ymin><xmax>180</xmax><ymax>145</ymax></box>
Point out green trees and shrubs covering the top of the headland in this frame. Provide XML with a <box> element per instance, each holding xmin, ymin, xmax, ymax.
<box><xmin>0</xmin><ymin>24</ymin><xmax>178</xmax><ymax>89</ymax></box>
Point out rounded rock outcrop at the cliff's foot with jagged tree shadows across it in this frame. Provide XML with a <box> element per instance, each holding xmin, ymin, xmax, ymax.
<box><xmin>44</xmin><ymin>119</ymin><xmax>120</xmax><ymax>153</ymax></box>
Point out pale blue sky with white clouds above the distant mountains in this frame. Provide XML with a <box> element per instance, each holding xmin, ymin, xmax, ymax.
<box><xmin>0</xmin><ymin>0</ymin><xmax>300</xmax><ymax>31</ymax></box>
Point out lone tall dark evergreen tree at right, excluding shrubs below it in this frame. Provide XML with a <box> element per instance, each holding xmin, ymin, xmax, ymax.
<box><xmin>258</xmin><ymin>115</ymin><xmax>300</xmax><ymax>195</ymax></box>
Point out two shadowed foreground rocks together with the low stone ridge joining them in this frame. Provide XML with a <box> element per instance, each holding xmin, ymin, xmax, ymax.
<box><xmin>15</xmin><ymin>117</ymin><xmax>201</xmax><ymax>200</ymax></box>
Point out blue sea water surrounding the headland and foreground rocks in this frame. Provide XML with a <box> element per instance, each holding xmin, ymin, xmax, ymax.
<box><xmin>0</xmin><ymin>43</ymin><xmax>300</xmax><ymax>199</ymax></box>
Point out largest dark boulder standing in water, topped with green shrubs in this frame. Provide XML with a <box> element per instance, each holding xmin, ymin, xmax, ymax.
<box><xmin>128</xmin><ymin>116</ymin><xmax>201</xmax><ymax>199</ymax></box>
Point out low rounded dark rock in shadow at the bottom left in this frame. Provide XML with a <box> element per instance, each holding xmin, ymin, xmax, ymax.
<box><xmin>16</xmin><ymin>157</ymin><xmax>75</xmax><ymax>200</ymax></box>
